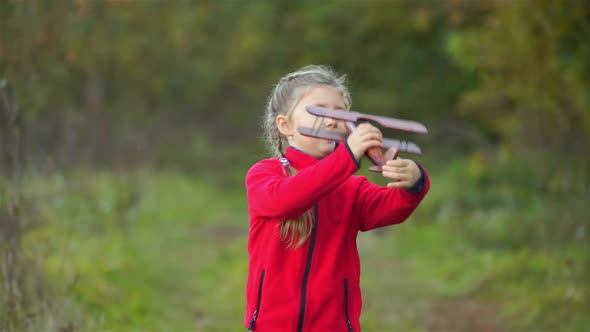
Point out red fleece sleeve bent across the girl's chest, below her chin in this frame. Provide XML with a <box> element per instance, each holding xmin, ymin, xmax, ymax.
<box><xmin>246</xmin><ymin>144</ymin><xmax>359</xmax><ymax>219</ymax></box>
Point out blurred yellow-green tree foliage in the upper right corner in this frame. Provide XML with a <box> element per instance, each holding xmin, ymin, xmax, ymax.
<box><xmin>447</xmin><ymin>0</ymin><xmax>590</xmax><ymax>183</ymax></box>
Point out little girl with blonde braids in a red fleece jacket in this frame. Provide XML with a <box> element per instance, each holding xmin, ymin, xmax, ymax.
<box><xmin>244</xmin><ymin>66</ymin><xmax>430</xmax><ymax>332</ymax></box>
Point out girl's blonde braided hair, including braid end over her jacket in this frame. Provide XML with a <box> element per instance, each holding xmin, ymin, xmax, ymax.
<box><xmin>263</xmin><ymin>65</ymin><xmax>351</xmax><ymax>248</ymax></box>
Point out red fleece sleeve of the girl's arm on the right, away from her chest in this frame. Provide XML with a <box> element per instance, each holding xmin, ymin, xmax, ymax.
<box><xmin>354</xmin><ymin>166</ymin><xmax>430</xmax><ymax>232</ymax></box>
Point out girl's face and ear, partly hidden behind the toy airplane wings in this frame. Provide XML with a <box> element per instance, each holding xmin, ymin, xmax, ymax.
<box><xmin>276</xmin><ymin>85</ymin><xmax>346</xmax><ymax>158</ymax></box>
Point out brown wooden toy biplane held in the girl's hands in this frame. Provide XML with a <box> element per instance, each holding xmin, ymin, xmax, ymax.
<box><xmin>297</xmin><ymin>106</ymin><xmax>428</xmax><ymax>172</ymax></box>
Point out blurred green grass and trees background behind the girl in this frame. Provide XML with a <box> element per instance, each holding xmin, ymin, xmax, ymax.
<box><xmin>0</xmin><ymin>0</ymin><xmax>590</xmax><ymax>332</ymax></box>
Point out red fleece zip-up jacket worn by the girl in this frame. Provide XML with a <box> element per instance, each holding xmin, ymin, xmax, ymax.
<box><xmin>244</xmin><ymin>144</ymin><xmax>430</xmax><ymax>332</ymax></box>
